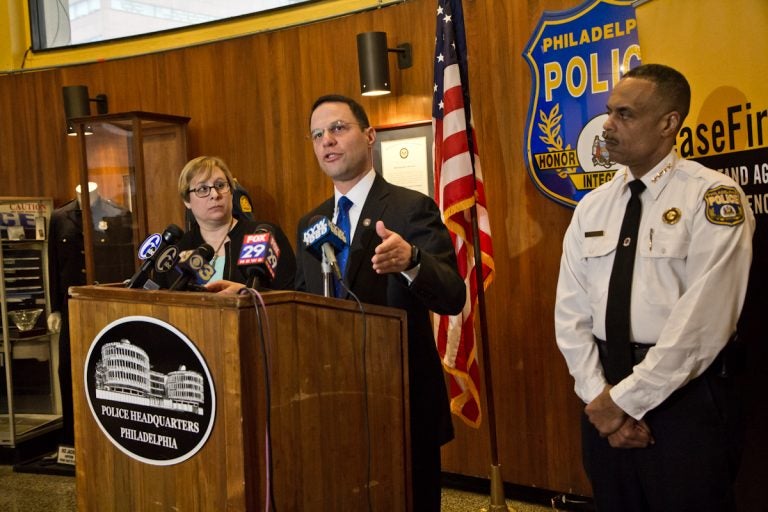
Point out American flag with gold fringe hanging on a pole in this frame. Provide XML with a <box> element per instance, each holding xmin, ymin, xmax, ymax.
<box><xmin>432</xmin><ymin>0</ymin><xmax>494</xmax><ymax>428</ymax></box>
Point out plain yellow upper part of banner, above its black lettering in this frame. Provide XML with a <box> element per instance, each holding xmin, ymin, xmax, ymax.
<box><xmin>637</xmin><ymin>0</ymin><xmax>768</xmax><ymax>156</ymax></box>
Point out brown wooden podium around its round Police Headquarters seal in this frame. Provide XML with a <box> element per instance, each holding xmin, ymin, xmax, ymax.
<box><xmin>69</xmin><ymin>286</ymin><xmax>411</xmax><ymax>512</ymax></box>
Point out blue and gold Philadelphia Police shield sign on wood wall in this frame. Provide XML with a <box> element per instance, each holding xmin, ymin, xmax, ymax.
<box><xmin>523</xmin><ymin>0</ymin><xmax>640</xmax><ymax>207</ymax></box>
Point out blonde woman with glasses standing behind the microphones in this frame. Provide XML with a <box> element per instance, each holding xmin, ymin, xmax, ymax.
<box><xmin>157</xmin><ymin>156</ymin><xmax>296</xmax><ymax>290</ymax></box>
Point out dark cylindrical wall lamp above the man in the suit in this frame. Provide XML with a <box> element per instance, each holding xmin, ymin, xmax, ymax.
<box><xmin>357</xmin><ymin>32</ymin><xmax>413</xmax><ymax>96</ymax></box>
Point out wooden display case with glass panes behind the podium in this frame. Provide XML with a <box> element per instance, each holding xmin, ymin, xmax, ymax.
<box><xmin>70</xmin><ymin>112</ymin><xmax>189</xmax><ymax>284</ymax></box>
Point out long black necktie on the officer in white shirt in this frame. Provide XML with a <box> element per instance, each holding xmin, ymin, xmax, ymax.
<box><xmin>603</xmin><ymin>180</ymin><xmax>645</xmax><ymax>384</ymax></box>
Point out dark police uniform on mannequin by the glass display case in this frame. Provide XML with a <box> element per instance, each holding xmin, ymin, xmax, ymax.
<box><xmin>48</xmin><ymin>182</ymin><xmax>135</xmax><ymax>445</ymax></box>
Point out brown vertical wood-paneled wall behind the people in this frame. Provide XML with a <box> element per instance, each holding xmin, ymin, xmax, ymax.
<box><xmin>0</xmin><ymin>0</ymin><xmax>589</xmax><ymax>494</ymax></box>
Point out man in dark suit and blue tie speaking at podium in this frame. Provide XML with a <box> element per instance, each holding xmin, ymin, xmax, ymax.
<box><xmin>296</xmin><ymin>95</ymin><xmax>466</xmax><ymax>512</ymax></box>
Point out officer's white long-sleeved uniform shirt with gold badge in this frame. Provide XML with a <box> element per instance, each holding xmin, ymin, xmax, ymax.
<box><xmin>555</xmin><ymin>151</ymin><xmax>755</xmax><ymax>419</ymax></box>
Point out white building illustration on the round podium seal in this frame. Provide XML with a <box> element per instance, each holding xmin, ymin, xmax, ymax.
<box><xmin>94</xmin><ymin>338</ymin><xmax>205</xmax><ymax>415</ymax></box>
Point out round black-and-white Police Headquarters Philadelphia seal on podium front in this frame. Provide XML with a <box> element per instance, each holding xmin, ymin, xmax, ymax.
<box><xmin>84</xmin><ymin>316</ymin><xmax>216</xmax><ymax>466</ymax></box>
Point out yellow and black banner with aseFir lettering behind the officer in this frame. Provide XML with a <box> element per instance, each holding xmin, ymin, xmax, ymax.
<box><xmin>636</xmin><ymin>7</ymin><xmax>768</xmax><ymax>504</ymax></box>
